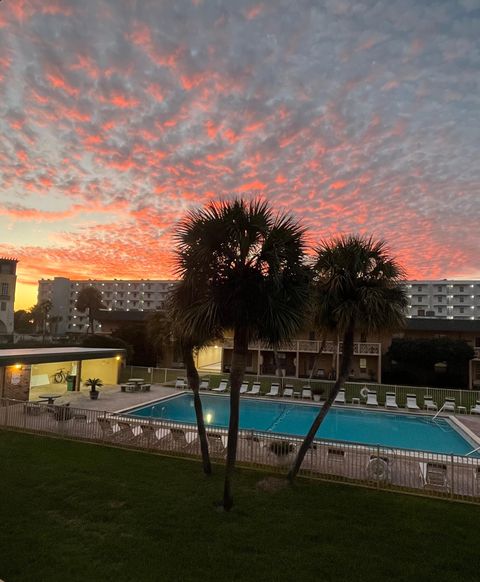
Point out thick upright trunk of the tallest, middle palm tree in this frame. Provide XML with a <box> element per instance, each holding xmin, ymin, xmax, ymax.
<box><xmin>223</xmin><ymin>327</ymin><xmax>248</xmax><ymax>511</ymax></box>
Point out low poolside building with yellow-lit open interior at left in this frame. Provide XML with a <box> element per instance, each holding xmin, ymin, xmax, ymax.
<box><xmin>0</xmin><ymin>347</ymin><xmax>125</xmax><ymax>401</ymax></box>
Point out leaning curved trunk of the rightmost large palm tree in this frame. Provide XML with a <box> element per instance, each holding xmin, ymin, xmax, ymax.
<box><xmin>287</xmin><ymin>322</ymin><xmax>355</xmax><ymax>483</ymax></box>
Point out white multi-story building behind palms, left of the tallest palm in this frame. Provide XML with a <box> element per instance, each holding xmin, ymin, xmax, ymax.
<box><xmin>38</xmin><ymin>277</ymin><xmax>175</xmax><ymax>335</ymax></box>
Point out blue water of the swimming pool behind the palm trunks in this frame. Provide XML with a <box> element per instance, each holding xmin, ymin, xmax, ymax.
<box><xmin>127</xmin><ymin>393</ymin><xmax>475</xmax><ymax>455</ymax></box>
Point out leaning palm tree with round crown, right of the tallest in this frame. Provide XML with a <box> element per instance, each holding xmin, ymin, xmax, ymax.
<box><xmin>288</xmin><ymin>235</ymin><xmax>408</xmax><ymax>481</ymax></box>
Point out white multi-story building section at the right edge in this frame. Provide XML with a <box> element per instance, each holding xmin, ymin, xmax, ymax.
<box><xmin>407</xmin><ymin>279</ymin><xmax>480</xmax><ymax>319</ymax></box>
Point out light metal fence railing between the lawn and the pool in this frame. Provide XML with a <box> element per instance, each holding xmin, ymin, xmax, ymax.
<box><xmin>0</xmin><ymin>399</ymin><xmax>480</xmax><ymax>503</ymax></box>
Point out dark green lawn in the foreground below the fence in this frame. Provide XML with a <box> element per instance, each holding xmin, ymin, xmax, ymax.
<box><xmin>0</xmin><ymin>431</ymin><xmax>480</xmax><ymax>582</ymax></box>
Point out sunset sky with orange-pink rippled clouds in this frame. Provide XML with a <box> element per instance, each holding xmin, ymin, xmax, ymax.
<box><xmin>0</xmin><ymin>0</ymin><xmax>480</xmax><ymax>309</ymax></box>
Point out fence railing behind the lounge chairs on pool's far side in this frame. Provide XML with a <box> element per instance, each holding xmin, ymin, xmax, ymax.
<box><xmin>122</xmin><ymin>366</ymin><xmax>480</xmax><ymax>413</ymax></box>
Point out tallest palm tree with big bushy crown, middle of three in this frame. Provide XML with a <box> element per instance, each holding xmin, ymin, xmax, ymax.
<box><xmin>176</xmin><ymin>199</ymin><xmax>308</xmax><ymax>511</ymax></box>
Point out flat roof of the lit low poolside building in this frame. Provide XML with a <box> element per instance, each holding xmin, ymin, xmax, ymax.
<box><xmin>0</xmin><ymin>348</ymin><xmax>125</xmax><ymax>367</ymax></box>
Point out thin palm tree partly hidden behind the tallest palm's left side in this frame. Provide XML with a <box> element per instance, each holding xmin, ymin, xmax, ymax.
<box><xmin>147</xmin><ymin>306</ymin><xmax>212</xmax><ymax>475</ymax></box>
